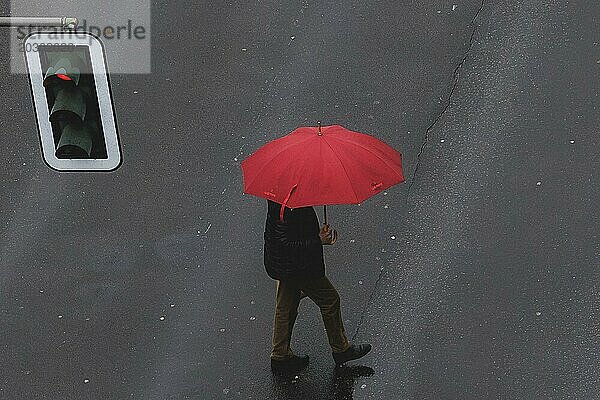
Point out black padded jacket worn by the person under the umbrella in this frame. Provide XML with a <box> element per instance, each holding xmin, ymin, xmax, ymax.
<box><xmin>264</xmin><ymin>200</ymin><xmax>325</xmax><ymax>281</ymax></box>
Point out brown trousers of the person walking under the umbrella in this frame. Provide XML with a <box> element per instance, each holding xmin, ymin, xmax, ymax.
<box><xmin>271</xmin><ymin>276</ymin><xmax>349</xmax><ymax>360</ymax></box>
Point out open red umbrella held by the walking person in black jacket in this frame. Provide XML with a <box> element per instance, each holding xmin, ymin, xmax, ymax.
<box><xmin>242</xmin><ymin>125</ymin><xmax>404</xmax><ymax>223</ymax></box>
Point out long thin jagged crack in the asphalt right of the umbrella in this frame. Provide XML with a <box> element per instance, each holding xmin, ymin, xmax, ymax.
<box><xmin>351</xmin><ymin>0</ymin><xmax>486</xmax><ymax>341</ymax></box>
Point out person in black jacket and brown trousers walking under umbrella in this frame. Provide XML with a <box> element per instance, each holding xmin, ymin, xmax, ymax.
<box><xmin>264</xmin><ymin>200</ymin><xmax>371</xmax><ymax>372</ymax></box>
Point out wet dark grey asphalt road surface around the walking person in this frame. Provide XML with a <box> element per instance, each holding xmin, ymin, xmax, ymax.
<box><xmin>0</xmin><ymin>0</ymin><xmax>600</xmax><ymax>400</ymax></box>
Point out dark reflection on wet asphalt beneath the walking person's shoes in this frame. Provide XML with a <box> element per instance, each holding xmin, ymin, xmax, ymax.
<box><xmin>273</xmin><ymin>365</ymin><xmax>375</xmax><ymax>400</ymax></box>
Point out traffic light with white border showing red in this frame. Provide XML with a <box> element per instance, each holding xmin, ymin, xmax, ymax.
<box><xmin>26</xmin><ymin>32</ymin><xmax>121</xmax><ymax>171</ymax></box>
